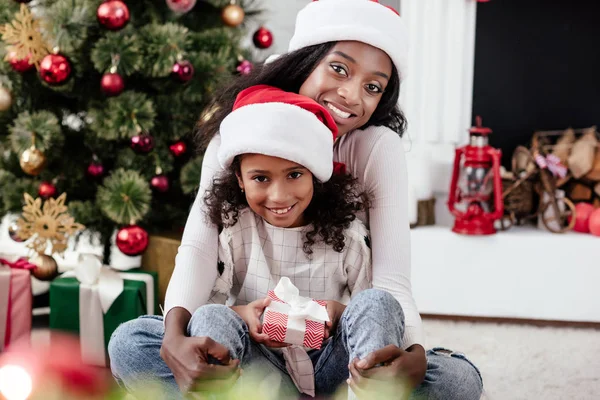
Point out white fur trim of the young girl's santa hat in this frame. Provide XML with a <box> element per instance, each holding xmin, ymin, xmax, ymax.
<box><xmin>217</xmin><ymin>103</ymin><xmax>333</xmax><ymax>182</ymax></box>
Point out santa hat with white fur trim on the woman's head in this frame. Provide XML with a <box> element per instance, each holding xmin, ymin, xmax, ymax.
<box><xmin>288</xmin><ymin>0</ymin><xmax>408</xmax><ymax>80</ymax></box>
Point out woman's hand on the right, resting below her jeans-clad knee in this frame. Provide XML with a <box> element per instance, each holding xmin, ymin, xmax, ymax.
<box><xmin>348</xmin><ymin>344</ymin><xmax>427</xmax><ymax>398</ymax></box>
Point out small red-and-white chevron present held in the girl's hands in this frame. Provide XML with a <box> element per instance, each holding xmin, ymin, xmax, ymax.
<box><xmin>263</xmin><ymin>277</ymin><xmax>329</xmax><ymax>349</ymax></box>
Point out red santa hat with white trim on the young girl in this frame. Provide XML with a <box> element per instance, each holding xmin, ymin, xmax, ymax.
<box><xmin>217</xmin><ymin>85</ymin><xmax>337</xmax><ymax>182</ymax></box>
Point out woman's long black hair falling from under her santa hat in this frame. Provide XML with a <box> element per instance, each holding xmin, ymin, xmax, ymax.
<box><xmin>194</xmin><ymin>42</ymin><xmax>406</xmax><ymax>151</ymax></box>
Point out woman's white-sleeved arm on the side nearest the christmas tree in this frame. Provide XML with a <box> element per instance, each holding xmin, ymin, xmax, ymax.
<box><xmin>164</xmin><ymin>135</ymin><xmax>221</xmax><ymax>322</ymax></box>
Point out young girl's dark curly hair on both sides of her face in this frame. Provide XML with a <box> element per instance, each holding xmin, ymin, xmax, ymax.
<box><xmin>204</xmin><ymin>157</ymin><xmax>369</xmax><ymax>256</ymax></box>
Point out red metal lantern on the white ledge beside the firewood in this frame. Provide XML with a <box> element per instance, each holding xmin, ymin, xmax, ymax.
<box><xmin>448</xmin><ymin>117</ymin><xmax>504</xmax><ymax>235</ymax></box>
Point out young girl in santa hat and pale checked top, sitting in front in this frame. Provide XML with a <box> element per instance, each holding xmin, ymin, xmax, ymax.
<box><xmin>203</xmin><ymin>85</ymin><xmax>376</xmax><ymax>397</ymax></box>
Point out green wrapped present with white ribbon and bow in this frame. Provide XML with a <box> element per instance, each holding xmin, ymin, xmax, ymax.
<box><xmin>50</xmin><ymin>254</ymin><xmax>158</xmax><ymax>366</ymax></box>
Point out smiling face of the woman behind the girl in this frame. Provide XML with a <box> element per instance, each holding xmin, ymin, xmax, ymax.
<box><xmin>300</xmin><ymin>41</ymin><xmax>392</xmax><ymax>136</ymax></box>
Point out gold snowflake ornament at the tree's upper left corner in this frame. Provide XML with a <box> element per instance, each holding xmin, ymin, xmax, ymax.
<box><xmin>0</xmin><ymin>4</ymin><xmax>50</xmax><ymax>68</ymax></box>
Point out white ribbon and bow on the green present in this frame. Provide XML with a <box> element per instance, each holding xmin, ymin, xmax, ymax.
<box><xmin>62</xmin><ymin>254</ymin><xmax>154</xmax><ymax>366</ymax></box>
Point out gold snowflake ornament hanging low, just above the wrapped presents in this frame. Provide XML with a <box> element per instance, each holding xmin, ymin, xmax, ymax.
<box><xmin>17</xmin><ymin>193</ymin><xmax>85</xmax><ymax>254</ymax></box>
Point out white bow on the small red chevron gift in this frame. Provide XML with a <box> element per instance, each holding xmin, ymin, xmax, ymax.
<box><xmin>270</xmin><ymin>276</ymin><xmax>329</xmax><ymax>322</ymax></box>
